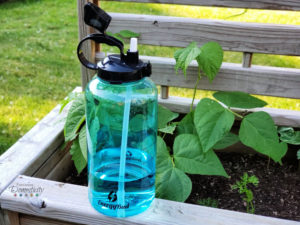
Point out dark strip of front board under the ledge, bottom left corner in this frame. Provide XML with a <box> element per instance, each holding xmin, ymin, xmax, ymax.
<box><xmin>20</xmin><ymin>214</ymin><xmax>74</xmax><ymax>225</ymax></box>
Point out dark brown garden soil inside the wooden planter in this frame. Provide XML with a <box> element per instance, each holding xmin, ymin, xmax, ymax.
<box><xmin>65</xmin><ymin>153</ymin><xmax>300</xmax><ymax>221</ymax></box>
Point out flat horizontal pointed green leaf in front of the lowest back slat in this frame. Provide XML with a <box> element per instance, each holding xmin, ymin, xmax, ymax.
<box><xmin>213</xmin><ymin>91</ymin><xmax>267</xmax><ymax>109</ymax></box>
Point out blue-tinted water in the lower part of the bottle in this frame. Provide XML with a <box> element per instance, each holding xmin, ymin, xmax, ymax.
<box><xmin>89</xmin><ymin>148</ymin><xmax>155</xmax><ymax>217</ymax></box>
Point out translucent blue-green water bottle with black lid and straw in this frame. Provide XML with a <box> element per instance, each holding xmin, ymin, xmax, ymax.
<box><xmin>77</xmin><ymin>3</ymin><xmax>157</xmax><ymax>217</ymax></box>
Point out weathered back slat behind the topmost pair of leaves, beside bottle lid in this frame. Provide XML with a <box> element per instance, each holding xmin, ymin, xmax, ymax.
<box><xmin>141</xmin><ymin>56</ymin><xmax>300</xmax><ymax>98</ymax></box>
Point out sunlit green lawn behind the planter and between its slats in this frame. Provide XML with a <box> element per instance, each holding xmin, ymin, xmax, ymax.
<box><xmin>0</xmin><ymin>0</ymin><xmax>300</xmax><ymax>154</ymax></box>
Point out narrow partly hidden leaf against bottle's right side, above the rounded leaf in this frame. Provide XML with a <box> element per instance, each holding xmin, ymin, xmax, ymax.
<box><xmin>156</xmin><ymin>136</ymin><xmax>173</xmax><ymax>173</ymax></box>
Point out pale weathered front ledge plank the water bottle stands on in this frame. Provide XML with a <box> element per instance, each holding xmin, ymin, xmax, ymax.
<box><xmin>0</xmin><ymin>176</ymin><xmax>300</xmax><ymax>225</ymax></box>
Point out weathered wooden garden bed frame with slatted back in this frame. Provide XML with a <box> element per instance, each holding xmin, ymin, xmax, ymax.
<box><xmin>0</xmin><ymin>0</ymin><xmax>300</xmax><ymax>225</ymax></box>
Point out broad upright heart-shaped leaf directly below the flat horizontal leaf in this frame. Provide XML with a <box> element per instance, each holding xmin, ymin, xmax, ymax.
<box><xmin>194</xmin><ymin>98</ymin><xmax>234</xmax><ymax>152</ymax></box>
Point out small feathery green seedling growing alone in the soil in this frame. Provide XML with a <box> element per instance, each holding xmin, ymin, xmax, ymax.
<box><xmin>231</xmin><ymin>173</ymin><xmax>259</xmax><ymax>214</ymax></box>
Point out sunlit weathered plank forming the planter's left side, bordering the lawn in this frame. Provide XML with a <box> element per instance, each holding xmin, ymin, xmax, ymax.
<box><xmin>0</xmin><ymin>106</ymin><xmax>66</xmax><ymax>193</ymax></box>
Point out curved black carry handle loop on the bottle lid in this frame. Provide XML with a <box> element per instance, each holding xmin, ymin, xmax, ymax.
<box><xmin>77</xmin><ymin>34</ymin><xmax>125</xmax><ymax>70</ymax></box>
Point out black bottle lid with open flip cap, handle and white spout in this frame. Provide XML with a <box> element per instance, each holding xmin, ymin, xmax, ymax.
<box><xmin>77</xmin><ymin>3</ymin><xmax>151</xmax><ymax>84</ymax></box>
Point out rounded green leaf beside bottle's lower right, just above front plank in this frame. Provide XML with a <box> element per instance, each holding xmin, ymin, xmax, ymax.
<box><xmin>155</xmin><ymin>167</ymin><xmax>192</xmax><ymax>202</ymax></box>
